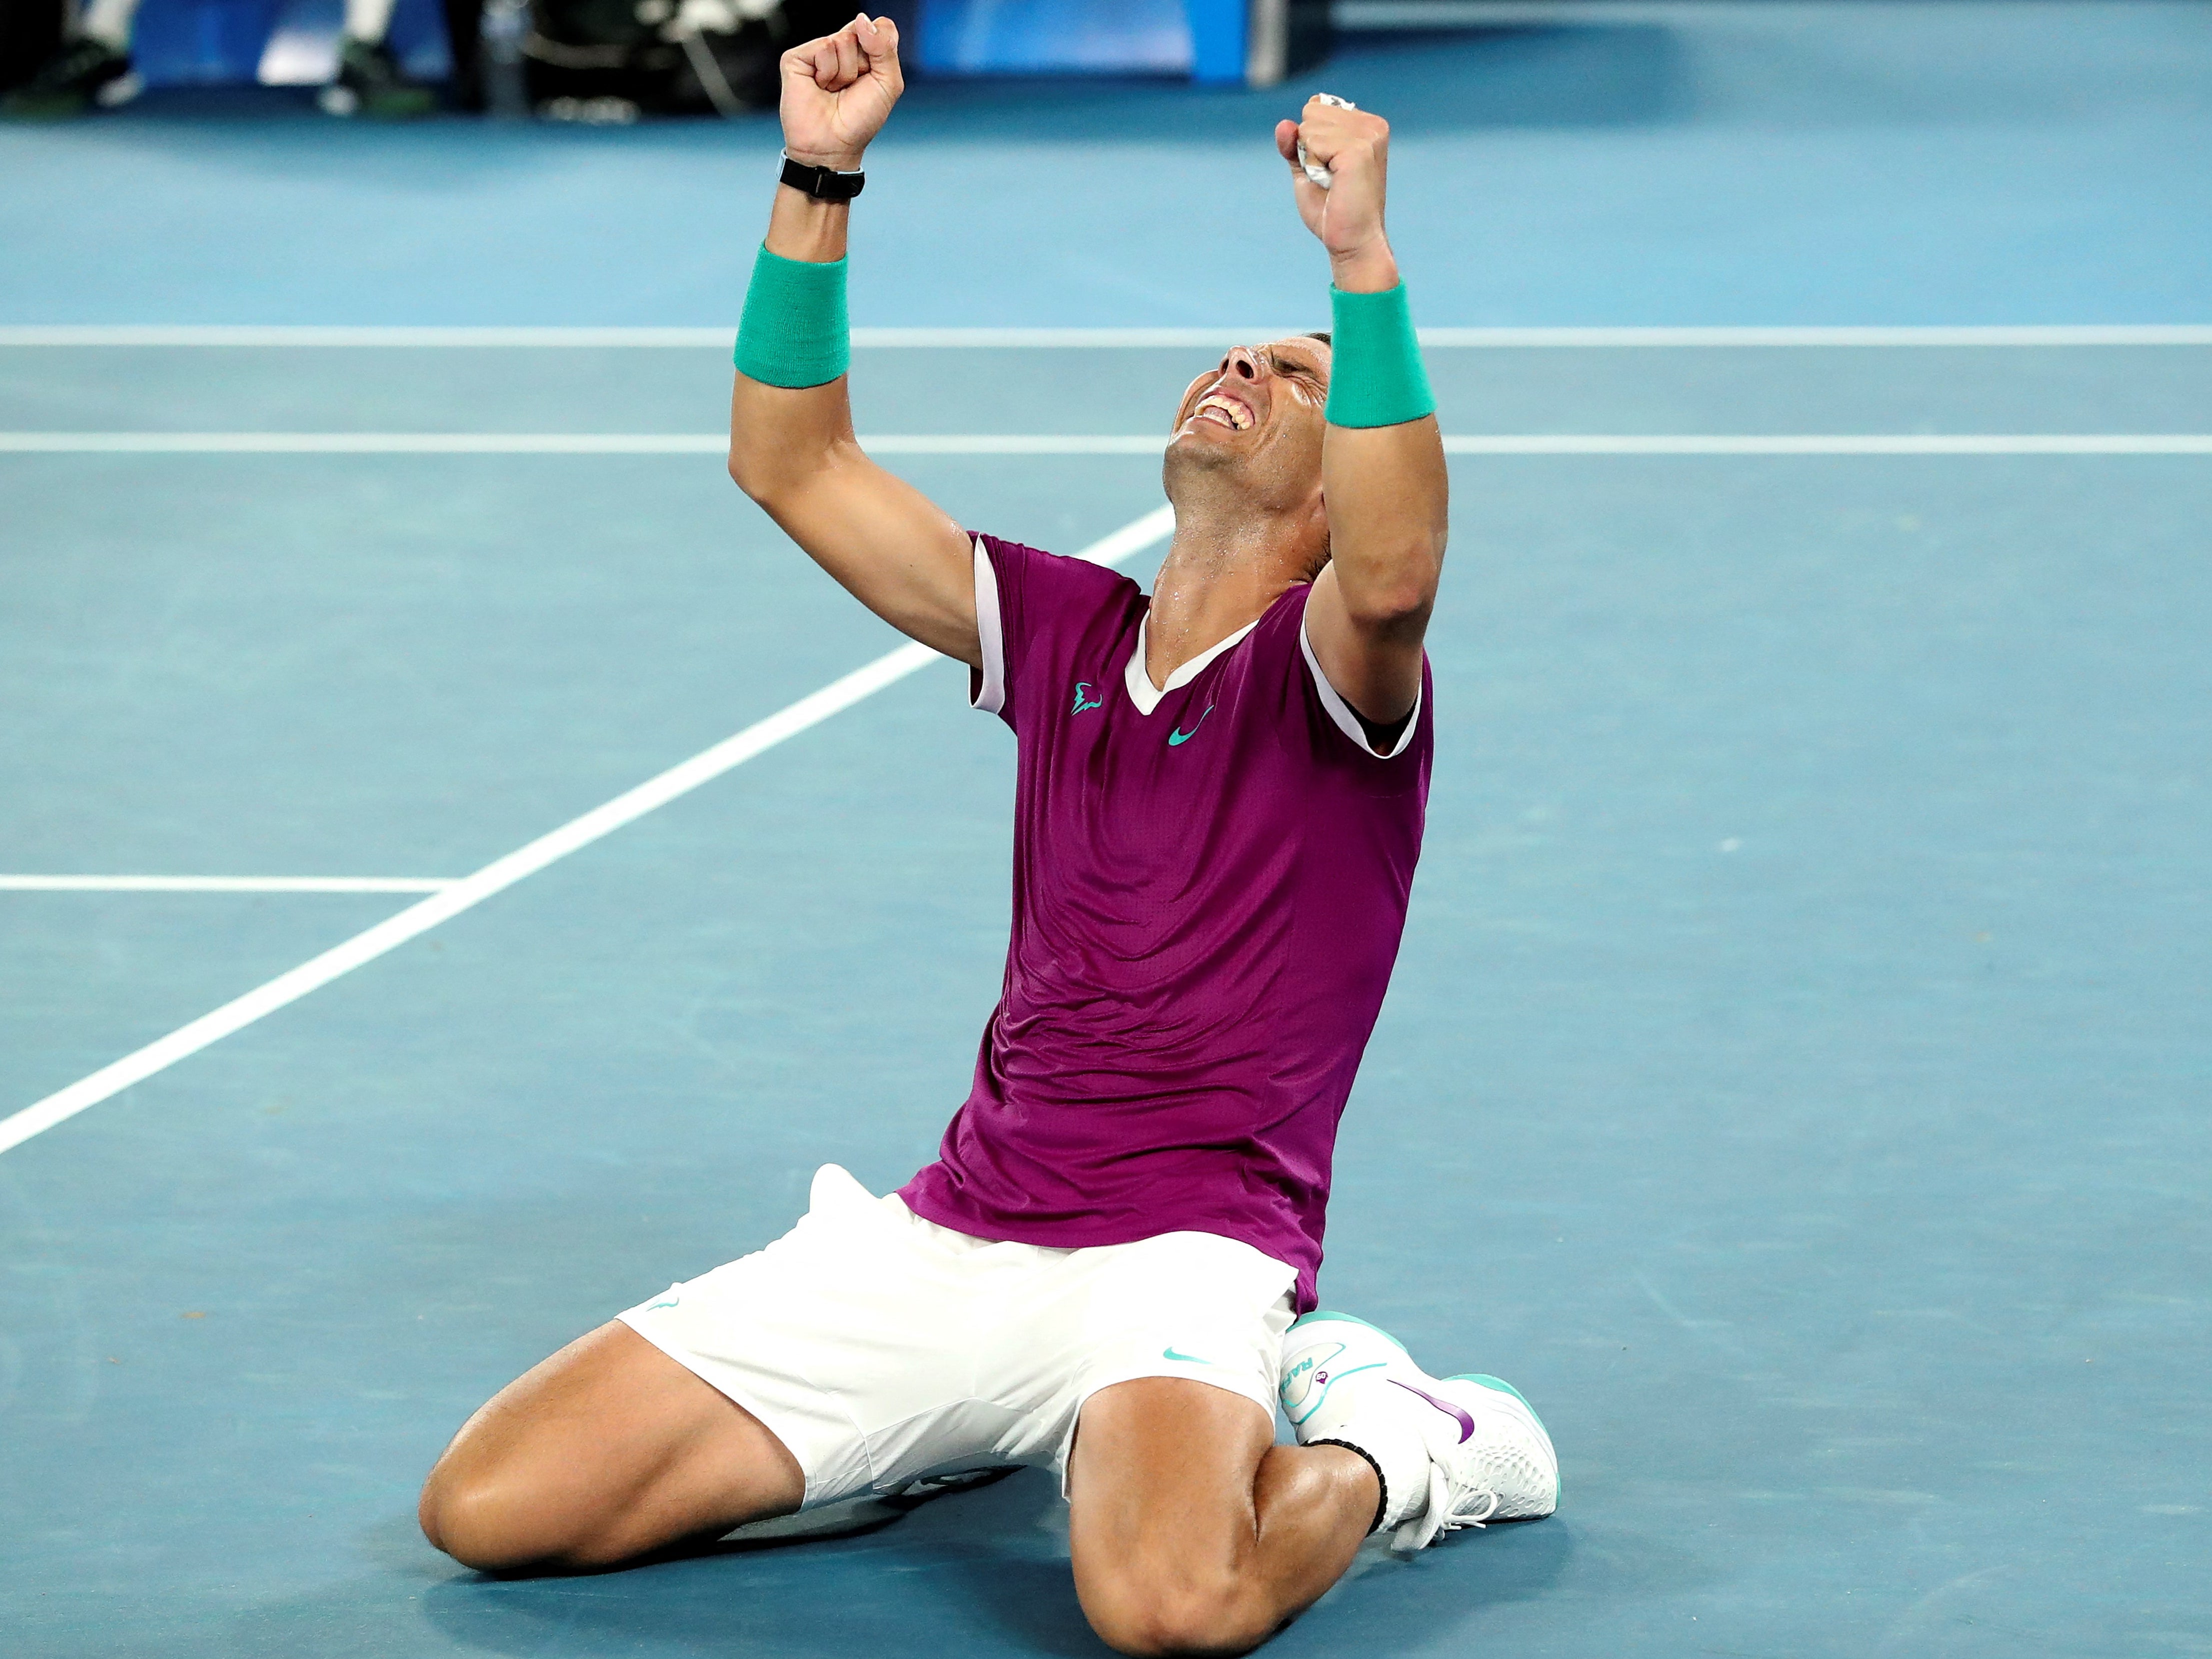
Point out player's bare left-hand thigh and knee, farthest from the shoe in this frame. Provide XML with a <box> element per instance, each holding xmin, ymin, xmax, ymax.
<box><xmin>418</xmin><ymin>1323</ymin><xmax>805</xmax><ymax>1573</ymax></box>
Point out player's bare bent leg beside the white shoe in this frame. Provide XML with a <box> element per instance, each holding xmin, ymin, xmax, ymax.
<box><xmin>1068</xmin><ymin>1376</ymin><xmax>1380</xmax><ymax>1654</ymax></box>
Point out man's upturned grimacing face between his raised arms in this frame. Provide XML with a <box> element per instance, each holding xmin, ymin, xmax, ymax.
<box><xmin>1168</xmin><ymin>336</ymin><xmax>1329</xmax><ymax>504</ymax></box>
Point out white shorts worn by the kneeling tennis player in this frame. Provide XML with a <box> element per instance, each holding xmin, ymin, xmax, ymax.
<box><xmin>622</xmin><ymin>1163</ymin><xmax>1296</xmax><ymax>1508</ymax></box>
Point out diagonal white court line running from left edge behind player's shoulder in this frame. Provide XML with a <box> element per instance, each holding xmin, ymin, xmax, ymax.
<box><xmin>0</xmin><ymin>507</ymin><xmax>1175</xmax><ymax>1152</ymax></box>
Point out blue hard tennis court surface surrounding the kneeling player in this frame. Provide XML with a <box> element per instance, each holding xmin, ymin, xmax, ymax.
<box><xmin>13</xmin><ymin>5</ymin><xmax>2212</xmax><ymax>1659</ymax></box>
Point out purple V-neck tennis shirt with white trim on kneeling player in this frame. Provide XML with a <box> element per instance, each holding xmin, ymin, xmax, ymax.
<box><xmin>900</xmin><ymin>535</ymin><xmax>1433</xmax><ymax>1312</ymax></box>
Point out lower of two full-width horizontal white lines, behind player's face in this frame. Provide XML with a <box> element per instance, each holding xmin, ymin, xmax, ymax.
<box><xmin>0</xmin><ymin>431</ymin><xmax>2212</xmax><ymax>456</ymax></box>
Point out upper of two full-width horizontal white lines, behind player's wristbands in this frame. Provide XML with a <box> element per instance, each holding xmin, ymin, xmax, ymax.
<box><xmin>0</xmin><ymin>319</ymin><xmax>2212</xmax><ymax>352</ymax></box>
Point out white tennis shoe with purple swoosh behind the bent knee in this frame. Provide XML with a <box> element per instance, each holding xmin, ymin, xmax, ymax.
<box><xmin>1281</xmin><ymin>1312</ymin><xmax>1559</xmax><ymax>1550</ymax></box>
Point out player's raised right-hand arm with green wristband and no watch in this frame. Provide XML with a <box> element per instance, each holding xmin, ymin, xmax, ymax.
<box><xmin>1274</xmin><ymin>100</ymin><xmax>1449</xmax><ymax>726</ymax></box>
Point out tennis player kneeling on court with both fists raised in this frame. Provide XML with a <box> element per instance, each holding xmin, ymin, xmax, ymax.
<box><xmin>420</xmin><ymin>16</ymin><xmax>1557</xmax><ymax>1654</ymax></box>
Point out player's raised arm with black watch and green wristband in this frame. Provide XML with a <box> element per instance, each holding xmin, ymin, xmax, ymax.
<box><xmin>730</xmin><ymin>16</ymin><xmax>982</xmax><ymax>668</ymax></box>
